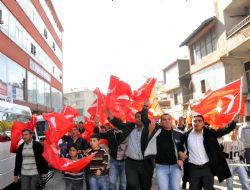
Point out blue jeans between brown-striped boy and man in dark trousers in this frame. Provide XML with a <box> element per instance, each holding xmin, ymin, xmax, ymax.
<box><xmin>109</xmin><ymin>158</ymin><xmax>127</xmax><ymax>190</ymax></box>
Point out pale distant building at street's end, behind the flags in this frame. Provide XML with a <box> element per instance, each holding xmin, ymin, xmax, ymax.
<box><xmin>64</xmin><ymin>89</ymin><xmax>96</xmax><ymax>121</ymax></box>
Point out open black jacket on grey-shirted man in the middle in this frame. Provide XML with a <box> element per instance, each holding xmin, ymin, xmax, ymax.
<box><xmin>109</xmin><ymin>107</ymin><xmax>148</xmax><ymax>158</ymax></box>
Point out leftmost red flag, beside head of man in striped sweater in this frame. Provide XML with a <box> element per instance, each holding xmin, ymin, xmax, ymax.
<box><xmin>10</xmin><ymin>115</ymin><xmax>37</xmax><ymax>153</ymax></box>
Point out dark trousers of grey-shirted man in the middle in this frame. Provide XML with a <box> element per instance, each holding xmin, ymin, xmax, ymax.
<box><xmin>125</xmin><ymin>158</ymin><xmax>154</xmax><ymax>190</ymax></box>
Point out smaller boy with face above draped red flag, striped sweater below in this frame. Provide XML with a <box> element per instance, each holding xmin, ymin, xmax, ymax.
<box><xmin>64</xmin><ymin>143</ymin><xmax>84</xmax><ymax>190</ymax></box>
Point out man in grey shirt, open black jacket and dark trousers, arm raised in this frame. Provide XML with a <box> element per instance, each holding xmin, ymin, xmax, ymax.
<box><xmin>106</xmin><ymin>107</ymin><xmax>153</xmax><ymax>190</ymax></box>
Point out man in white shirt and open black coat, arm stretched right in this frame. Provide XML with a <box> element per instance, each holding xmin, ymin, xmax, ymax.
<box><xmin>184</xmin><ymin>115</ymin><xmax>238</xmax><ymax>190</ymax></box>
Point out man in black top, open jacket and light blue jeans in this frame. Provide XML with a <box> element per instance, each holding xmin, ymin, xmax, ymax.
<box><xmin>142</xmin><ymin>102</ymin><xmax>184</xmax><ymax>190</ymax></box>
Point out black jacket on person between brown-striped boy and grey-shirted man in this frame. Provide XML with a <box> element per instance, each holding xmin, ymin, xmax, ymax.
<box><xmin>94</xmin><ymin>127</ymin><xmax>122</xmax><ymax>160</ymax></box>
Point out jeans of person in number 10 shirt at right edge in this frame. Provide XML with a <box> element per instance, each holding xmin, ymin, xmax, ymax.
<box><xmin>226</xmin><ymin>166</ymin><xmax>250</xmax><ymax>190</ymax></box>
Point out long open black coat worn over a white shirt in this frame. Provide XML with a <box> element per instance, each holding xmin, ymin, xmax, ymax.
<box><xmin>184</xmin><ymin>121</ymin><xmax>236</xmax><ymax>182</ymax></box>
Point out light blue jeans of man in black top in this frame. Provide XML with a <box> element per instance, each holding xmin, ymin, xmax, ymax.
<box><xmin>156</xmin><ymin>164</ymin><xmax>181</xmax><ymax>190</ymax></box>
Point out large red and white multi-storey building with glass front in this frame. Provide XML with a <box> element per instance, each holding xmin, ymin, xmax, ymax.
<box><xmin>0</xmin><ymin>0</ymin><xmax>63</xmax><ymax>112</ymax></box>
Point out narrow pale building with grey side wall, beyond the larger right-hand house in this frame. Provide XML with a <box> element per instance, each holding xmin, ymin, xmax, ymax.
<box><xmin>159</xmin><ymin>59</ymin><xmax>192</xmax><ymax>119</ymax></box>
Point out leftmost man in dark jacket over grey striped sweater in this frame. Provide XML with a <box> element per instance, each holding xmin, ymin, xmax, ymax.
<box><xmin>14</xmin><ymin>129</ymin><xmax>48</xmax><ymax>190</ymax></box>
